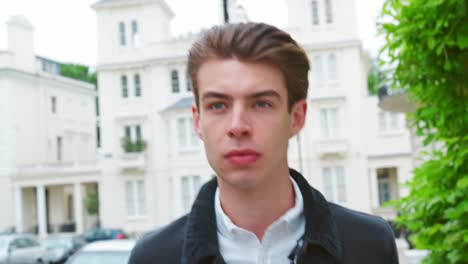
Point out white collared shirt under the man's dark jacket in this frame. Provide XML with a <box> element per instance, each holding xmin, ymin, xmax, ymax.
<box><xmin>215</xmin><ymin>177</ymin><xmax>305</xmax><ymax>264</ymax></box>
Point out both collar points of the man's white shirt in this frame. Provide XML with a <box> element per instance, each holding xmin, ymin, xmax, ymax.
<box><xmin>215</xmin><ymin>176</ymin><xmax>304</xmax><ymax>237</ymax></box>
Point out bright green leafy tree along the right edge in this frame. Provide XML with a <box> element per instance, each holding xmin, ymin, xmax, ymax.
<box><xmin>379</xmin><ymin>0</ymin><xmax>468</xmax><ymax>263</ymax></box>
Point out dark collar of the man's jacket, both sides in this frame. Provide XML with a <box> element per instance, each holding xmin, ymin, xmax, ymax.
<box><xmin>182</xmin><ymin>169</ymin><xmax>342</xmax><ymax>264</ymax></box>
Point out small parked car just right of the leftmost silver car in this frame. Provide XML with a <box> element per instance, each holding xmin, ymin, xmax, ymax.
<box><xmin>42</xmin><ymin>234</ymin><xmax>86</xmax><ymax>264</ymax></box>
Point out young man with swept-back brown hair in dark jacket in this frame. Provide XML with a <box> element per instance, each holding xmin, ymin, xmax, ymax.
<box><xmin>130</xmin><ymin>23</ymin><xmax>398</xmax><ymax>264</ymax></box>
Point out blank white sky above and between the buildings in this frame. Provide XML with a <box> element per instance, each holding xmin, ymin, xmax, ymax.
<box><xmin>0</xmin><ymin>0</ymin><xmax>384</xmax><ymax>66</ymax></box>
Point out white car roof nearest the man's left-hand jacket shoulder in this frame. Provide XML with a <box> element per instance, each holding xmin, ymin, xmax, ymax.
<box><xmin>66</xmin><ymin>239</ymin><xmax>135</xmax><ymax>264</ymax></box>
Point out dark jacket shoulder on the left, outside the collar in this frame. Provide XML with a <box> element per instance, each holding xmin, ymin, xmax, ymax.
<box><xmin>129</xmin><ymin>216</ymin><xmax>187</xmax><ymax>264</ymax></box>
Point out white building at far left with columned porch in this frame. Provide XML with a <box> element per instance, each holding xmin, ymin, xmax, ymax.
<box><xmin>0</xmin><ymin>16</ymin><xmax>100</xmax><ymax>238</ymax></box>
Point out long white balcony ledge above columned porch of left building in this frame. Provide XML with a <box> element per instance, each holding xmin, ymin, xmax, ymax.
<box><xmin>16</xmin><ymin>160</ymin><xmax>100</xmax><ymax>177</ymax></box>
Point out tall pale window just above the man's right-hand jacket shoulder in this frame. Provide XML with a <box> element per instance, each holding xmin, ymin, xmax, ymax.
<box><xmin>322</xmin><ymin>167</ymin><xmax>347</xmax><ymax>203</ymax></box>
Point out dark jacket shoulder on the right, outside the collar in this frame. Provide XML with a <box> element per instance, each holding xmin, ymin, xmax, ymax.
<box><xmin>329</xmin><ymin>203</ymin><xmax>398</xmax><ymax>263</ymax></box>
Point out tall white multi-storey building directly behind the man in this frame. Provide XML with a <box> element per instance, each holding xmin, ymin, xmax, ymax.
<box><xmin>93</xmin><ymin>0</ymin><xmax>412</xmax><ymax>233</ymax></box>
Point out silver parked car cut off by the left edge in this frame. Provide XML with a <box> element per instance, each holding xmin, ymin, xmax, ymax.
<box><xmin>0</xmin><ymin>234</ymin><xmax>47</xmax><ymax>264</ymax></box>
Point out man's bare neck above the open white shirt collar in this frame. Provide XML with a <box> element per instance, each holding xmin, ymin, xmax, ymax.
<box><xmin>218</xmin><ymin>170</ymin><xmax>294</xmax><ymax>241</ymax></box>
